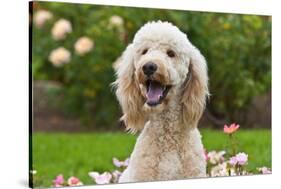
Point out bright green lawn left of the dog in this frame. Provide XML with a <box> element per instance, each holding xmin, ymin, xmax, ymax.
<box><xmin>32</xmin><ymin>133</ymin><xmax>135</xmax><ymax>187</ymax></box>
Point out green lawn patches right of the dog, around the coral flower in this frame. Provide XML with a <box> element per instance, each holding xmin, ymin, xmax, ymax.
<box><xmin>201</xmin><ymin>130</ymin><xmax>271</xmax><ymax>171</ymax></box>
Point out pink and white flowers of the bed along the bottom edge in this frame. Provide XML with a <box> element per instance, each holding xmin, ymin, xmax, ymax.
<box><xmin>31</xmin><ymin>124</ymin><xmax>271</xmax><ymax>187</ymax></box>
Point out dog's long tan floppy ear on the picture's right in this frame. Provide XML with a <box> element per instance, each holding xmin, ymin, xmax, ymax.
<box><xmin>182</xmin><ymin>47</ymin><xmax>209</xmax><ymax>127</ymax></box>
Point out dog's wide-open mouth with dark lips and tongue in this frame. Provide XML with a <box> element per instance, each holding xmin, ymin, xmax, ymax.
<box><xmin>145</xmin><ymin>80</ymin><xmax>172</xmax><ymax>106</ymax></box>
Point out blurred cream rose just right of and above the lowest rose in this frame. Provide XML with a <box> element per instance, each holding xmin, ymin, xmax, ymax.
<box><xmin>74</xmin><ymin>37</ymin><xmax>94</xmax><ymax>56</ymax></box>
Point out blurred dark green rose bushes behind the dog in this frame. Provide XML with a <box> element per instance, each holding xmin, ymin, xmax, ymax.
<box><xmin>32</xmin><ymin>2</ymin><xmax>271</xmax><ymax>127</ymax></box>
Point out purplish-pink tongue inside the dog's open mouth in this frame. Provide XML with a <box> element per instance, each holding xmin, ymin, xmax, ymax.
<box><xmin>146</xmin><ymin>81</ymin><xmax>163</xmax><ymax>104</ymax></box>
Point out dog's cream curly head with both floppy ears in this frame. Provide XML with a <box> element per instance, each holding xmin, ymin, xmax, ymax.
<box><xmin>112</xmin><ymin>21</ymin><xmax>208</xmax><ymax>130</ymax></box>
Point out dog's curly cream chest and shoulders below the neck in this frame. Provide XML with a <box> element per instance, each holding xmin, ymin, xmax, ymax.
<box><xmin>127</xmin><ymin>127</ymin><xmax>206</xmax><ymax>182</ymax></box>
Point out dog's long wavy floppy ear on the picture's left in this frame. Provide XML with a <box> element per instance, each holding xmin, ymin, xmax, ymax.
<box><xmin>113</xmin><ymin>44</ymin><xmax>145</xmax><ymax>132</ymax></box>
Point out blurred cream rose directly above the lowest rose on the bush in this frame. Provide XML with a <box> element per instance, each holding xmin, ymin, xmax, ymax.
<box><xmin>52</xmin><ymin>19</ymin><xmax>72</xmax><ymax>40</ymax></box>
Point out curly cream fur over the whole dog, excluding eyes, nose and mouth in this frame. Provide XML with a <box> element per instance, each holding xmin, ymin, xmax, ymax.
<box><xmin>114</xmin><ymin>21</ymin><xmax>209</xmax><ymax>182</ymax></box>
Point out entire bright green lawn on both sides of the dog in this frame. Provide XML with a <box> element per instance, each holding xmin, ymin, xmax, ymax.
<box><xmin>33</xmin><ymin>129</ymin><xmax>271</xmax><ymax>187</ymax></box>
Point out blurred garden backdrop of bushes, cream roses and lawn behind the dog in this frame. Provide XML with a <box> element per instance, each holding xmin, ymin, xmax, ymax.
<box><xmin>29</xmin><ymin>2</ymin><xmax>271</xmax><ymax>186</ymax></box>
